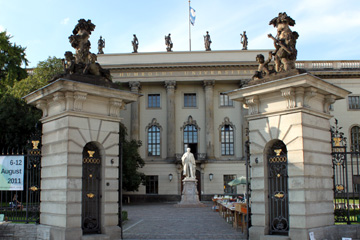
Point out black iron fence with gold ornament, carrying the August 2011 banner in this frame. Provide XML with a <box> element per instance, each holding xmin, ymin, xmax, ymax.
<box><xmin>0</xmin><ymin>130</ymin><xmax>41</xmax><ymax>223</ymax></box>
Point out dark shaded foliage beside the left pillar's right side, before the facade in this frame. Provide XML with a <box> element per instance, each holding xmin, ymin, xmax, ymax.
<box><xmin>120</xmin><ymin>124</ymin><xmax>145</xmax><ymax>192</ymax></box>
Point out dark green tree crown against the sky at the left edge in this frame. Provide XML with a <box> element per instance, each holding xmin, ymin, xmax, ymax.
<box><xmin>0</xmin><ymin>32</ymin><xmax>28</xmax><ymax>93</ymax></box>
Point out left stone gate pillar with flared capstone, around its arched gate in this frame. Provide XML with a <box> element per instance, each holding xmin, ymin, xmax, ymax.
<box><xmin>25</xmin><ymin>79</ymin><xmax>138</xmax><ymax>240</ymax></box>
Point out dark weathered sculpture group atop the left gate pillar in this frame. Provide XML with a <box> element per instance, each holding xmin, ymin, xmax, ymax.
<box><xmin>50</xmin><ymin>19</ymin><xmax>115</xmax><ymax>87</ymax></box>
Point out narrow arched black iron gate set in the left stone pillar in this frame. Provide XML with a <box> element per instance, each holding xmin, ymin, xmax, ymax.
<box><xmin>81</xmin><ymin>143</ymin><xmax>101</xmax><ymax>234</ymax></box>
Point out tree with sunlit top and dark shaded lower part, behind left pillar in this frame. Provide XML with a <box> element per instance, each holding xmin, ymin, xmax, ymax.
<box><xmin>0</xmin><ymin>57</ymin><xmax>62</xmax><ymax>151</ymax></box>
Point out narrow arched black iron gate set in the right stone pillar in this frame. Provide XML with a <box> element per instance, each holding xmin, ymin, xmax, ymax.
<box><xmin>268</xmin><ymin>141</ymin><xmax>289</xmax><ymax>235</ymax></box>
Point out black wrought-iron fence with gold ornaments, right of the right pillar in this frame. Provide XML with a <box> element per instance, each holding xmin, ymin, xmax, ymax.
<box><xmin>330</xmin><ymin>119</ymin><xmax>360</xmax><ymax>224</ymax></box>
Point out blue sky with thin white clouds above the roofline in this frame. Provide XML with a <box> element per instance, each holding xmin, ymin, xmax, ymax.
<box><xmin>0</xmin><ymin>0</ymin><xmax>360</xmax><ymax>67</ymax></box>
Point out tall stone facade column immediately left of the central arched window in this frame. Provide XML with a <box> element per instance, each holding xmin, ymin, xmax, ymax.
<box><xmin>165</xmin><ymin>81</ymin><xmax>176</xmax><ymax>159</ymax></box>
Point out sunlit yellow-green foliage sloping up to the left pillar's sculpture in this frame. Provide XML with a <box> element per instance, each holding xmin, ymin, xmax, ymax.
<box><xmin>8</xmin><ymin>57</ymin><xmax>64</xmax><ymax>98</ymax></box>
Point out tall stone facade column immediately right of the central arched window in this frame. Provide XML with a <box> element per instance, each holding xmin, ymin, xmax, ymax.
<box><xmin>204</xmin><ymin>80</ymin><xmax>215</xmax><ymax>159</ymax></box>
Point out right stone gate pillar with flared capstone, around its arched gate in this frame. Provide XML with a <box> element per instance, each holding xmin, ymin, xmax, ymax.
<box><xmin>228</xmin><ymin>74</ymin><xmax>349</xmax><ymax>240</ymax></box>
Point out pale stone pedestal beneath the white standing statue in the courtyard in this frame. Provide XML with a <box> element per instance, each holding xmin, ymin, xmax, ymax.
<box><xmin>178</xmin><ymin>178</ymin><xmax>203</xmax><ymax>207</ymax></box>
